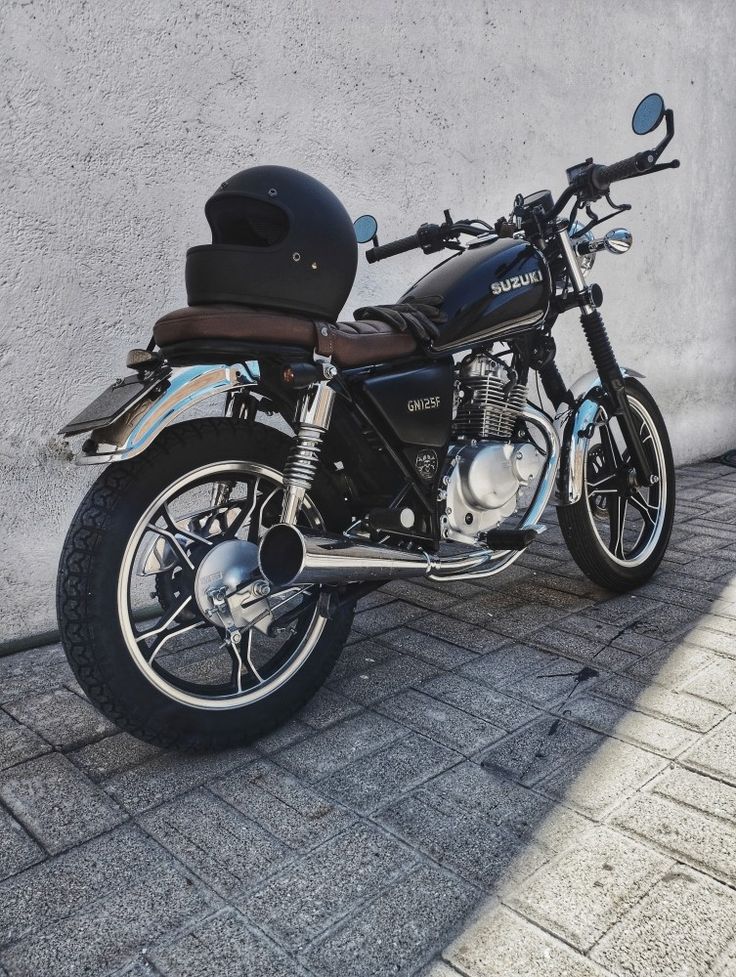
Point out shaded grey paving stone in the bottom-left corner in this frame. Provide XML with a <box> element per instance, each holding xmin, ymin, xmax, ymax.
<box><xmin>1</xmin><ymin>866</ymin><xmax>216</xmax><ymax>977</ymax></box>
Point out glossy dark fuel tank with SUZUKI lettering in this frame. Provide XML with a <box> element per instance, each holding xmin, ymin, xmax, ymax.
<box><xmin>400</xmin><ymin>238</ymin><xmax>551</xmax><ymax>352</ymax></box>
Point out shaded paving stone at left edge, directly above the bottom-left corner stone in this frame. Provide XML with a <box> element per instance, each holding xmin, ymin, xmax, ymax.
<box><xmin>0</xmin><ymin>824</ymin><xmax>183</xmax><ymax>944</ymax></box>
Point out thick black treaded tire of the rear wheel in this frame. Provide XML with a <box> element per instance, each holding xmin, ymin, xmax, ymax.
<box><xmin>57</xmin><ymin>418</ymin><xmax>354</xmax><ymax>751</ymax></box>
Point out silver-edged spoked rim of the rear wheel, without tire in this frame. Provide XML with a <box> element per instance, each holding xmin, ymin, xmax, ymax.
<box><xmin>118</xmin><ymin>461</ymin><xmax>326</xmax><ymax>709</ymax></box>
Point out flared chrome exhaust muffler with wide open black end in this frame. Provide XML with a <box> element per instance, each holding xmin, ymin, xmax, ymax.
<box><xmin>258</xmin><ymin>523</ymin><xmax>434</xmax><ymax>587</ymax></box>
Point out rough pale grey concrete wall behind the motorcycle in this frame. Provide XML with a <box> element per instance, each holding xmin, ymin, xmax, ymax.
<box><xmin>0</xmin><ymin>0</ymin><xmax>736</xmax><ymax>640</ymax></box>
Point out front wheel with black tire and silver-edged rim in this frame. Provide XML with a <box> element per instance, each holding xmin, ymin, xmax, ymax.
<box><xmin>557</xmin><ymin>378</ymin><xmax>675</xmax><ymax>591</ymax></box>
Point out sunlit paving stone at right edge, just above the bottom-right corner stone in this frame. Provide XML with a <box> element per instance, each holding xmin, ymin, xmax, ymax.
<box><xmin>611</xmin><ymin>793</ymin><xmax>736</xmax><ymax>880</ymax></box>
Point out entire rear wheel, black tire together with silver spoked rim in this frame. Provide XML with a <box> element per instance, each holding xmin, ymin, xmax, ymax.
<box><xmin>57</xmin><ymin>419</ymin><xmax>354</xmax><ymax>751</ymax></box>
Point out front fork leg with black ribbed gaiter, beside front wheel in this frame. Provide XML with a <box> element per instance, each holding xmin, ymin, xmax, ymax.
<box><xmin>557</xmin><ymin>221</ymin><xmax>657</xmax><ymax>486</ymax></box>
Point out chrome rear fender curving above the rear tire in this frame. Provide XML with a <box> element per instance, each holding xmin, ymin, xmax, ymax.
<box><xmin>75</xmin><ymin>362</ymin><xmax>260</xmax><ymax>465</ymax></box>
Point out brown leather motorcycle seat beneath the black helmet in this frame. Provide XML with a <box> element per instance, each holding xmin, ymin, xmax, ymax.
<box><xmin>153</xmin><ymin>305</ymin><xmax>416</xmax><ymax>367</ymax></box>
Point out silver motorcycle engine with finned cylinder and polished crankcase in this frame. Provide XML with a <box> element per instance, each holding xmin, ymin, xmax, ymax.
<box><xmin>440</xmin><ymin>353</ymin><xmax>546</xmax><ymax>543</ymax></box>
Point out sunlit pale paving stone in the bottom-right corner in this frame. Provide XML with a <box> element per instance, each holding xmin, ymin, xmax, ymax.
<box><xmin>591</xmin><ymin>869</ymin><xmax>736</xmax><ymax>977</ymax></box>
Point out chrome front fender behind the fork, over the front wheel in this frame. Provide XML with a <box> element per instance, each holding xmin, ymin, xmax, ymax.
<box><xmin>555</xmin><ymin>367</ymin><xmax>644</xmax><ymax>505</ymax></box>
